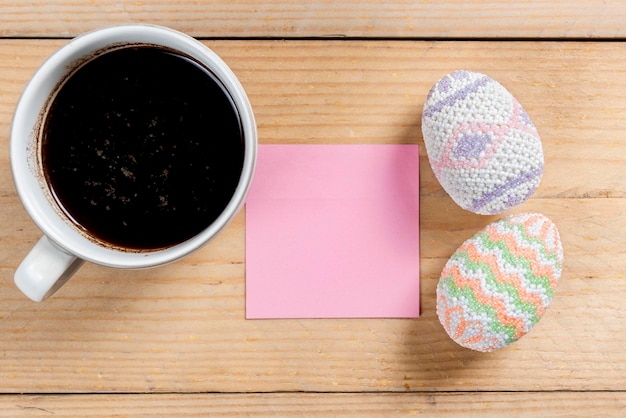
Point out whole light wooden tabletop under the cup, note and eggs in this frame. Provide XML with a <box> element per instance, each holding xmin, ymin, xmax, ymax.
<box><xmin>0</xmin><ymin>0</ymin><xmax>626</xmax><ymax>417</ymax></box>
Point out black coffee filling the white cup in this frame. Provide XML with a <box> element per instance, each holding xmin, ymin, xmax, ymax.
<box><xmin>41</xmin><ymin>46</ymin><xmax>244</xmax><ymax>249</ymax></box>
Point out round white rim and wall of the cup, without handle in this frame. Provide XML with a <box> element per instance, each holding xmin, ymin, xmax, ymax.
<box><xmin>10</xmin><ymin>24</ymin><xmax>258</xmax><ymax>268</ymax></box>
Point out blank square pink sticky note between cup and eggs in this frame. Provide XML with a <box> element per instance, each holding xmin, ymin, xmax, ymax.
<box><xmin>246</xmin><ymin>145</ymin><xmax>420</xmax><ymax>318</ymax></box>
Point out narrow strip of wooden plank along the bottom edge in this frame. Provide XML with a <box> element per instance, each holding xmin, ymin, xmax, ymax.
<box><xmin>0</xmin><ymin>392</ymin><xmax>626</xmax><ymax>418</ymax></box>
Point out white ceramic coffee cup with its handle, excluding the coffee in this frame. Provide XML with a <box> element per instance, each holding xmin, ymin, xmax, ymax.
<box><xmin>10</xmin><ymin>24</ymin><xmax>257</xmax><ymax>301</ymax></box>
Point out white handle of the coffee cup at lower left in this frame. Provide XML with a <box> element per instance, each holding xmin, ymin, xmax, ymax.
<box><xmin>14</xmin><ymin>235</ymin><xmax>84</xmax><ymax>302</ymax></box>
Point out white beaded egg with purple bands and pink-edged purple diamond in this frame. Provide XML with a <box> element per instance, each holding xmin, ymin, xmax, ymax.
<box><xmin>422</xmin><ymin>71</ymin><xmax>543</xmax><ymax>215</ymax></box>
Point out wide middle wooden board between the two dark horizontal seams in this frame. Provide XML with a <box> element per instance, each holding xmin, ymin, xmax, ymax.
<box><xmin>0</xmin><ymin>40</ymin><xmax>626</xmax><ymax>392</ymax></box>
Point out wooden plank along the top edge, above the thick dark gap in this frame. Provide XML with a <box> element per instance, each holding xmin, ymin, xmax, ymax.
<box><xmin>0</xmin><ymin>0</ymin><xmax>626</xmax><ymax>38</ymax></box>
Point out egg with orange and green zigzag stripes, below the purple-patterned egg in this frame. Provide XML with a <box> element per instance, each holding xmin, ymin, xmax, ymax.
<box><xmin>437</xmin><ymin>213</ymin><xmax>563</xmax><ymax>352</ymax></box>
